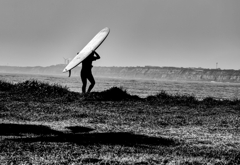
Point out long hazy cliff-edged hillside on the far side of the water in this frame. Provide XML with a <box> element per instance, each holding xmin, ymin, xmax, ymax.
<box><xmin>0</xmin><ymin>64</ymin><xmax>240</xmax><ymax>83</ymax></box>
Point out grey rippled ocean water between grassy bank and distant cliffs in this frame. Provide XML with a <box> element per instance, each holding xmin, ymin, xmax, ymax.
<box><xmin>0</xmin><ymin>73</ymin><xmax>240</xmax><ymax>99</ymax></box>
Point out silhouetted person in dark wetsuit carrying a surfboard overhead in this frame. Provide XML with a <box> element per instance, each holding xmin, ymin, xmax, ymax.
<box><xmin>77</xmin><ymin>51</ymin><xmax>100</xmax><ymax>93</ymax></box>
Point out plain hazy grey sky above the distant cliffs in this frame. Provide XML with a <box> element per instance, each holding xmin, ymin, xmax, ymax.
<box><xmin>0</xmin><ymin>0</ymin><xmax>240</xmax><ymax>69</ymax></box>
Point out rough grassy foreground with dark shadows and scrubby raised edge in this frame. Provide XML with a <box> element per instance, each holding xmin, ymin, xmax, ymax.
<box><xmin>0</xmin><ymin>80</ymin><xmax>240</xmax><ymax>165</ymax></box>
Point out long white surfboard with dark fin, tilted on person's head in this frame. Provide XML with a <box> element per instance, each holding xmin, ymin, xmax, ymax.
<box><xmin>63</xmin><ymin>27</ymin><xmax>110</xmax><ymax>77</ymax></box>
